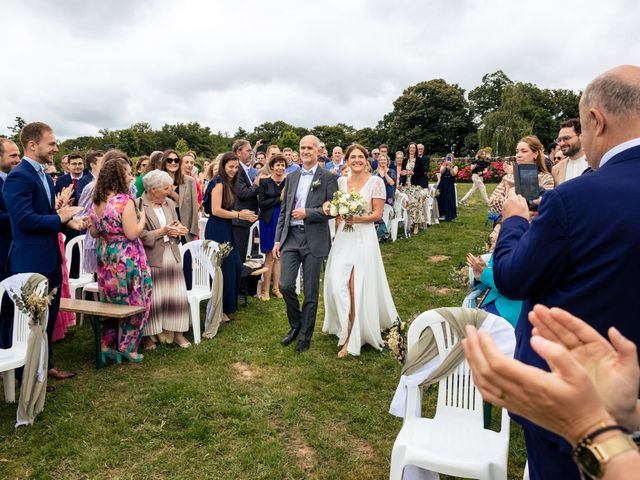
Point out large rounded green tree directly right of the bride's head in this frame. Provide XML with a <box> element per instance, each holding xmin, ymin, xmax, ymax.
<box><xmin>382</xmin><ymin>79</ymin><xmax>475</xmax><ymax>153</ymax></box>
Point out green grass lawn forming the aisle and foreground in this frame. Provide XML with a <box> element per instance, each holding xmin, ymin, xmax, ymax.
<box><xmin>0</xmin><ymin>185</ymin><xmax>525</xmax><ymax>479</ymax></box>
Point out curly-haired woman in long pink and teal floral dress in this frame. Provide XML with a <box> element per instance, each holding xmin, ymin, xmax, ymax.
<box><xmin>90</xmin><ymin>150</ymin><xmax>151</xmax><ymax>363</ymax></box>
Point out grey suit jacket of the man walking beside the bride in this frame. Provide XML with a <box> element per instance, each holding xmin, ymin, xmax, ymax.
<box><xmin>275</xmin><ymin>165</ymin><xmax>338</xmax><ymax>257</ymax></box>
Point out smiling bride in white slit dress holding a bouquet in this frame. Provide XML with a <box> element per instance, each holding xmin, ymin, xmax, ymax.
<box><xmin>322</xmin><ymin>144</ymin><xmax>398</xmax><ymax>357</ymax></box>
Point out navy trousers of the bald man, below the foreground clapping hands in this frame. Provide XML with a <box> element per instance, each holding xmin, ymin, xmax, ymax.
<box><xmin>523</xmin><ymin>426</ymin><xmax>580</xmax><ymax>480</ymax></box>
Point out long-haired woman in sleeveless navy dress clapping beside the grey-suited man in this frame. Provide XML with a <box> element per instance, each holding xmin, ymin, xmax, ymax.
<box><xmin>203</xmin><ymin>152</ymin><xmax>258</xmax><ymax>321</ymax></box>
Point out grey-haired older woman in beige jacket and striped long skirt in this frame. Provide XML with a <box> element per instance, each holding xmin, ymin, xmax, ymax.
<box><xmin>139</xmin><ymin>170</ymin><xmax>191</xmax><ymax>349</ymax></box>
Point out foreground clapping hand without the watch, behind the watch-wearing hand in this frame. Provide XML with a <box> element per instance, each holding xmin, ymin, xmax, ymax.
<box><xmin>529</xmin><ymin>305</ymin><xmax>640</xmax><ymax>429</ymax></box>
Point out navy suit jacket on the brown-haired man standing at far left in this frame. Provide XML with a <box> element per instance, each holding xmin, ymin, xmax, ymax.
<box><xmin>3</xmin><ymin>160</ymin><xmax>62</xmax><ymax>275</ymax></box>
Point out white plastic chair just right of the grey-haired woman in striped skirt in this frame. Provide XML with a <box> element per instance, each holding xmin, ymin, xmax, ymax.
<box><xmin>180</xmin><ymin>242</ymin><xmax>218</xmax><ymax>344</ymax></box>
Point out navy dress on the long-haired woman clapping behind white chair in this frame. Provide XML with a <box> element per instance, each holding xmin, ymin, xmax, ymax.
<box><xmin>203</xmin><ymin>177</ymin><xmax>242</xmax><ymax>315</ymax></box>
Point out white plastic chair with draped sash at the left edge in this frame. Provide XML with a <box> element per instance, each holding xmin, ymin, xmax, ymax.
<box><xmin>0</xmin><ymin>280</ymin><xmax>48</xmax><ymax>402</ymax></box>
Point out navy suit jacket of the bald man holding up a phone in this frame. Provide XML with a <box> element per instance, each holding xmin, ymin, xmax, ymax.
<box><xmin>493</xmin><ymin>142</ymin><xmax>640</xmax><ymax>438</ymax></box>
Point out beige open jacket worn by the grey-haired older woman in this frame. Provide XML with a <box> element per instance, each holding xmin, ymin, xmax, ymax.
<box><xmin>136</xmin><ymin>197</ymin><xmax>181</xmax><ymax>267</ymax></box>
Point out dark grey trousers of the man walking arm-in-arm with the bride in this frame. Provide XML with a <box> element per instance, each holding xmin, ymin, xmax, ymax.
<box><xmin>280</xmin><ymin>226</ymin><xmax>324</xmax><ymax>341</ymax></box>
